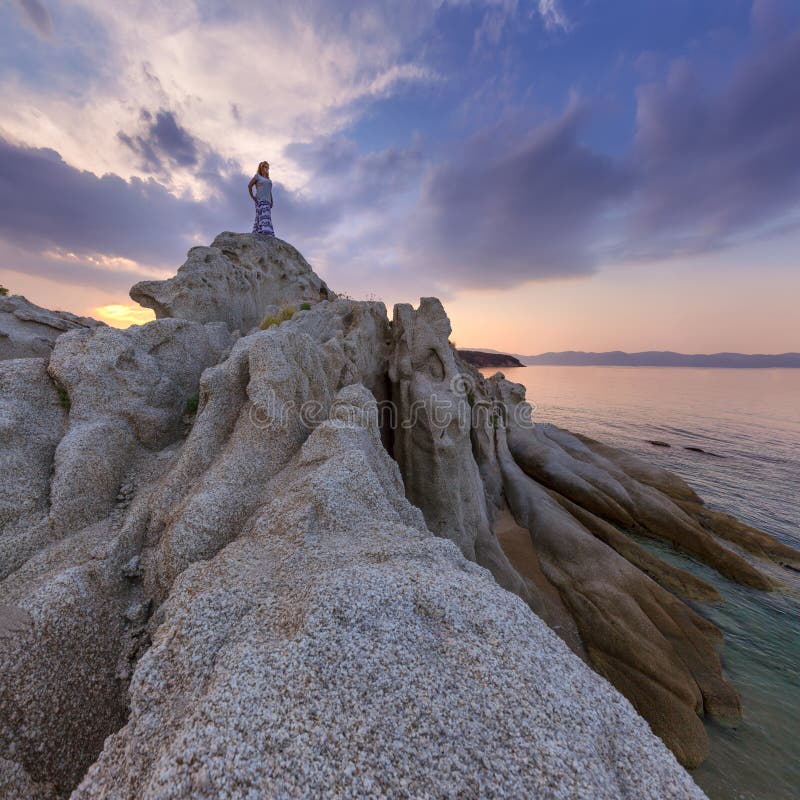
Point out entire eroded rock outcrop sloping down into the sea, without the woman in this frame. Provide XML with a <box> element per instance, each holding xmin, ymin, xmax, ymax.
<box><xmin>0</xmin><ymin>233</ymin><xmax>798</xmax><ymax>799</ymax></box>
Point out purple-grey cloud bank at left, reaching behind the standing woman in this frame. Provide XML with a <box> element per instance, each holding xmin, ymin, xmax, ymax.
<box><xmin>0</xmin><ymin>134</ymin><xmax>340</xmax><ymax>291</ymax></box>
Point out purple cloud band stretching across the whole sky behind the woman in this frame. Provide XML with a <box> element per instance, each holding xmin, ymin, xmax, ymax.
<box><xmin>0</xmin><ymin>17</ymin><xmax>800</xmax><ymax>302</ymax></box>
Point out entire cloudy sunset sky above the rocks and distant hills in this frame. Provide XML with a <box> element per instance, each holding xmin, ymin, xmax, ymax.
<box><xmin>0</xmin><ymin>0</ymin><xmax>800</xmax><ymax>354</ymax></box>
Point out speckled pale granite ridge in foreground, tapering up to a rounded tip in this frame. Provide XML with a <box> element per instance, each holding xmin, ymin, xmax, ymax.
<box><xmin>73</xmin><ymin>385</ymin><xmax>703</xmax><ymax>800</ymax></box>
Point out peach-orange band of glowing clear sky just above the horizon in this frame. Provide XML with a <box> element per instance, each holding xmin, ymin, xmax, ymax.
<box><xmin>0</xmin><ymin>250</ymin><xmax>800</xmax><ymax>355</ymax></box>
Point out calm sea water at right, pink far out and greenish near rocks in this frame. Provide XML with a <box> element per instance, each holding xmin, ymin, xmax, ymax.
<box><xmin>484</xmin><ymin>367</ymin><xmax>800</xmax><ymax>800</ymax></box>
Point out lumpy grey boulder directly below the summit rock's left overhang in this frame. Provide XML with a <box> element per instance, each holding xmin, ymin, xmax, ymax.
<box><xmin>49</xmin><ymin>319</ymin><xmax>233</xmax><ymax>531</ymax></box>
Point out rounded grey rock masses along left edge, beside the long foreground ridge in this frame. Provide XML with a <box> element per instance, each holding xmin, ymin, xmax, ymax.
<box><xmin>0</xmin><ymin>320</ymin><xmax>232</xmax><ymax>796</ymax></box>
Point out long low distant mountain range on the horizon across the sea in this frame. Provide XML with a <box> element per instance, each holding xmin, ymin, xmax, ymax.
<box><xmin>518</xmin><ymin>350</ymin><xmax>800</xmax><ymax>369</ymax></box>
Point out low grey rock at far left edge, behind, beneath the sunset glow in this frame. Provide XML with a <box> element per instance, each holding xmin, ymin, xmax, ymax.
<box><xmin>0</xmin><ymin>295</ymin><xmax>104</xmax><ymax>361</ymax></box>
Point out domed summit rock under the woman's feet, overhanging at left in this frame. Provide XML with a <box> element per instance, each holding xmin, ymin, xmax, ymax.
<box><xmin>130</xmin><ymin>233</ymin><xmax>336</xmax><ymax>333</ymax></box>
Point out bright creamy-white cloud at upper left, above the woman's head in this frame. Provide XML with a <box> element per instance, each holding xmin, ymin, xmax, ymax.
<box><xmin>0</xmin><ymin>0</ymin><xmax>438</xmax><ymax>188</ymax></box>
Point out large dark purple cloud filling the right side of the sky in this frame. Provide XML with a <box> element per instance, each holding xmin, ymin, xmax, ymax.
<box><xmin>409</xmin><ymin>21</ymin><xmax>800</xmax><ymax>287</ymax></box>
